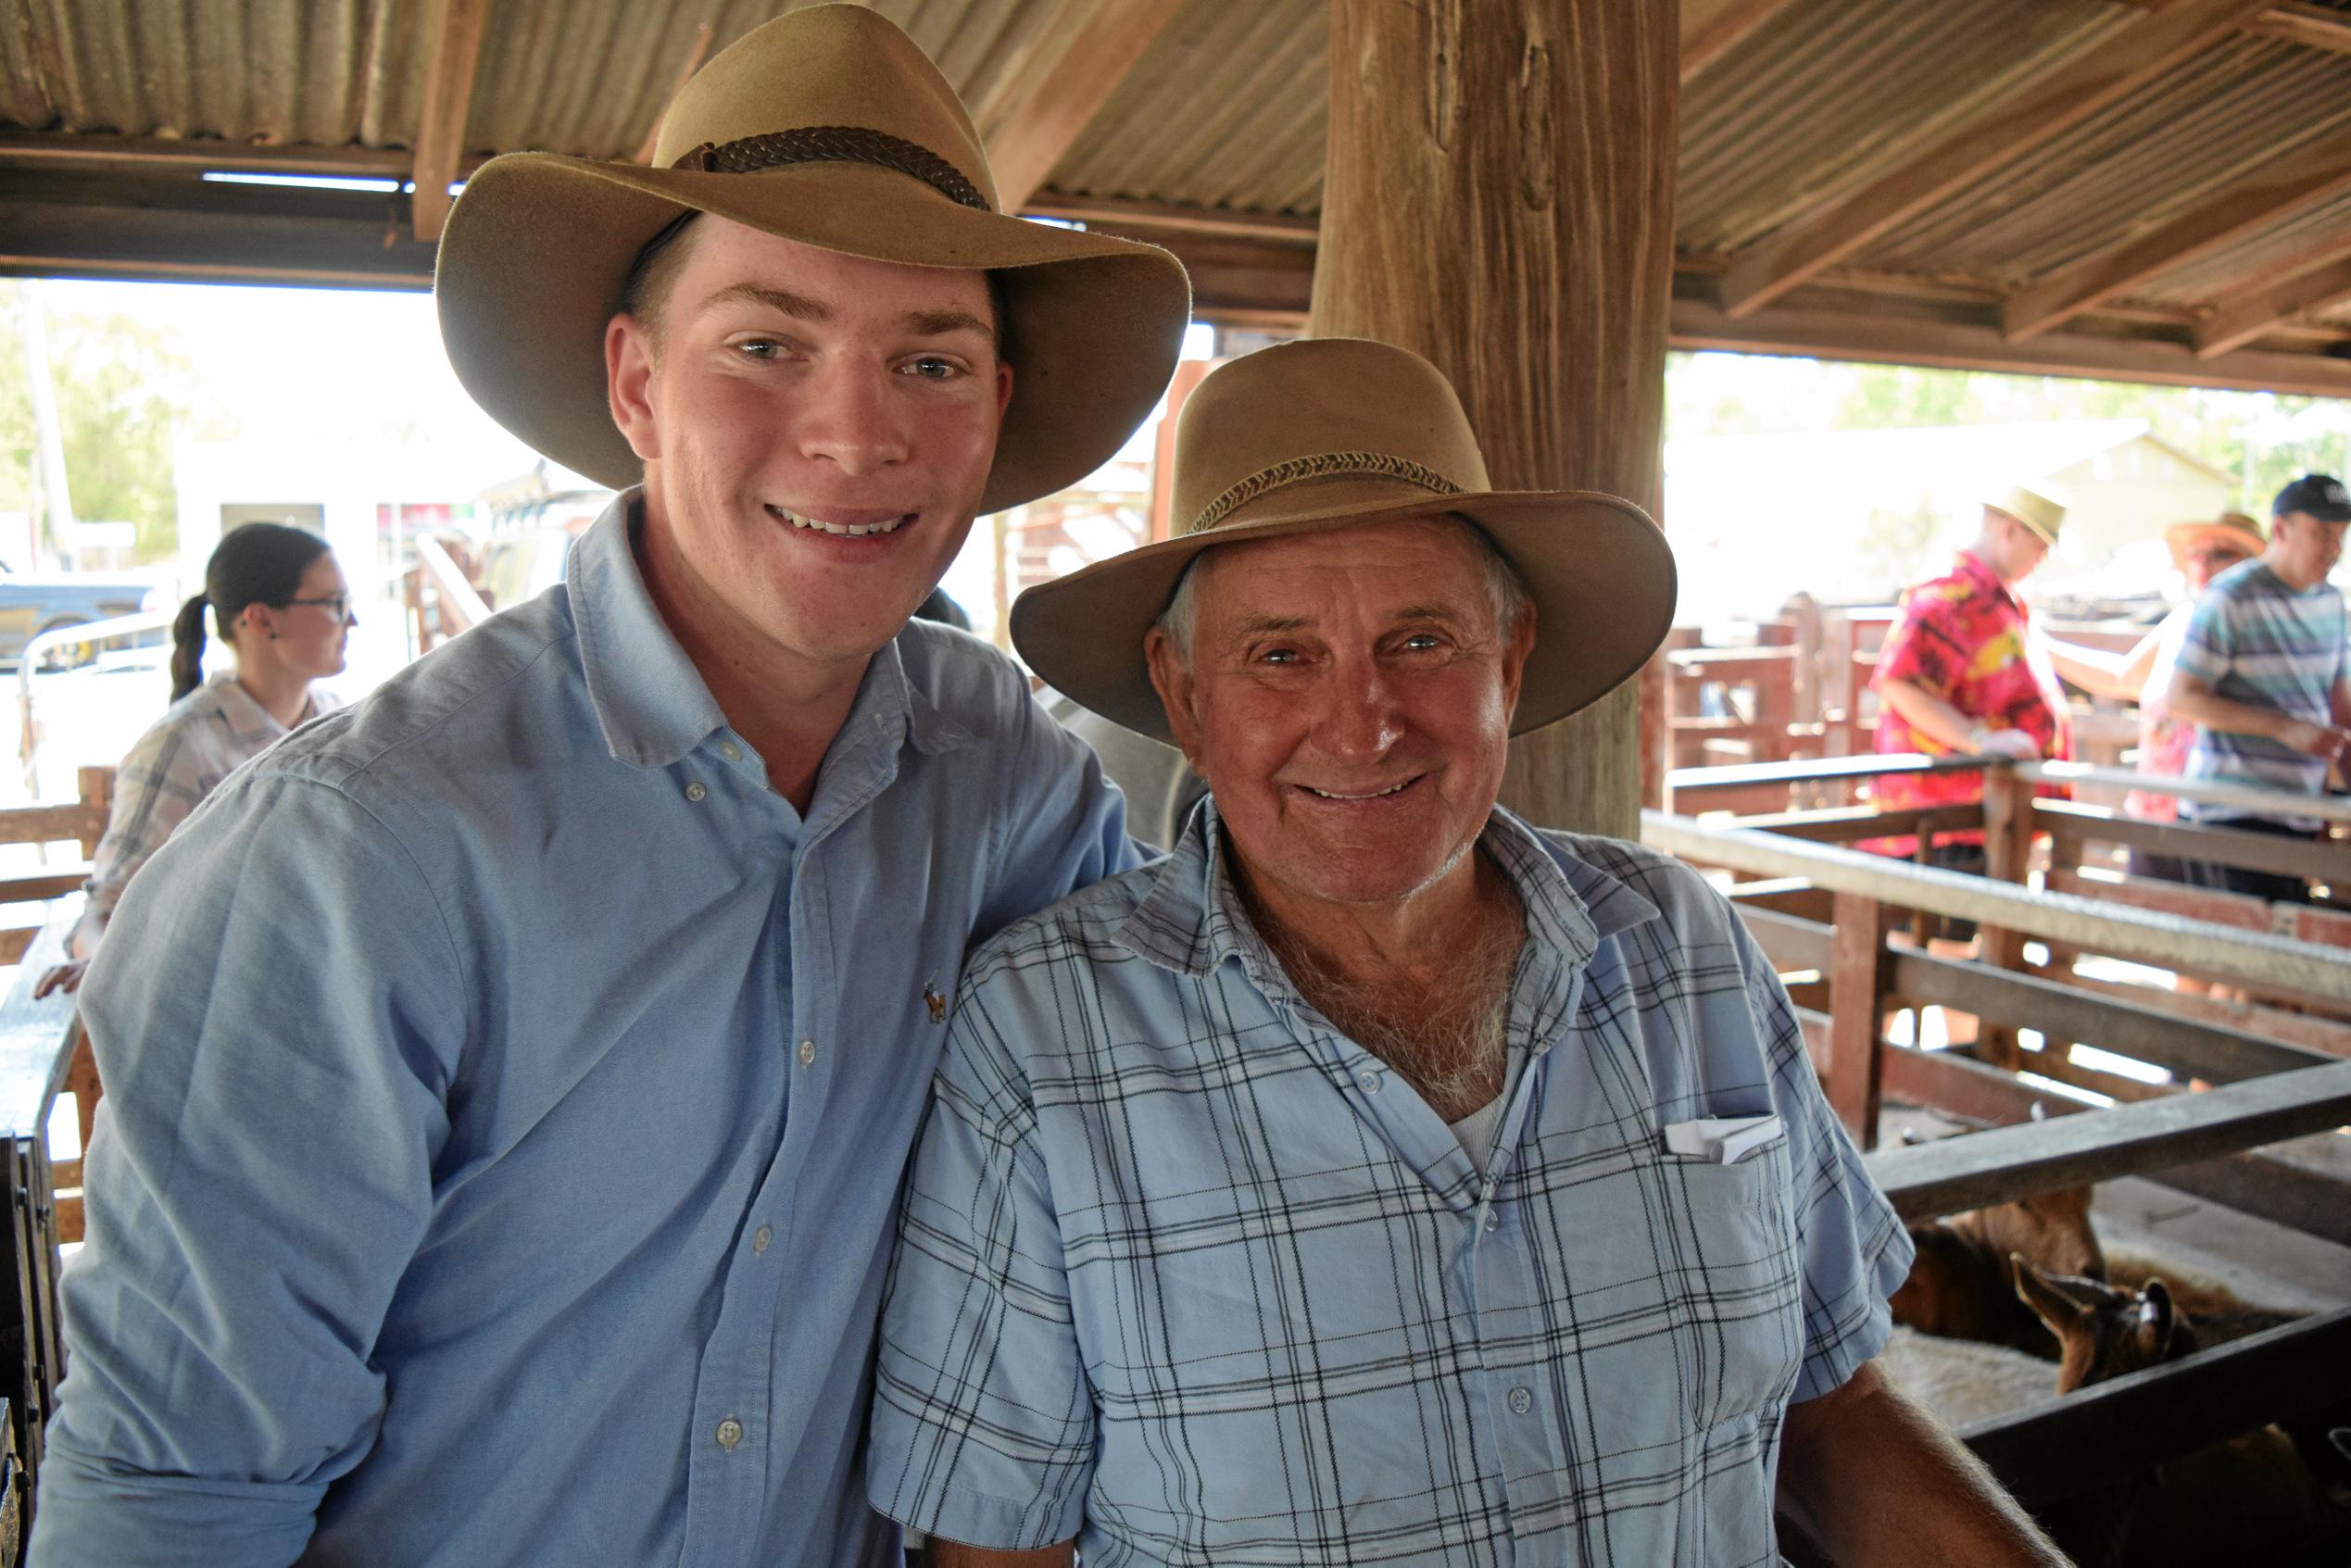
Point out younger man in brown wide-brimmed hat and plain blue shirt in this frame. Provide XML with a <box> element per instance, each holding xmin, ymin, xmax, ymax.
<box><xmin>33</xmin><ymin>5</ymin><xmax>1188</xmax><ymax>1568</ymax></box>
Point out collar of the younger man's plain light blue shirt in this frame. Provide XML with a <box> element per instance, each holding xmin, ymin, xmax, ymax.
<box><xmin>564</xmin><ymin>489</ymin><xmax>974</xmax><ymax>766</ymax></box>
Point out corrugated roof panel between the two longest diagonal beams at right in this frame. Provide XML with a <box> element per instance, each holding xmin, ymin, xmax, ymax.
<box><xmin>1865</xmin><ymin>38</ymin><xmax>2351</xmax><ymax>287</ymax></box>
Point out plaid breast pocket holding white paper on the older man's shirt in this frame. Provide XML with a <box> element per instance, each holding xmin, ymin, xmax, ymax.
<box><xmin>1655</xmin><ymin>1133</ymin><xmax>1804</xmax><ymax>1432</ymax></box>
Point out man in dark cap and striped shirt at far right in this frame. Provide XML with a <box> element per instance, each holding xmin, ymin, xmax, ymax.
<box><xmin>2165</xmin><ymin>475</ymin><xmax>2351</xmax><ymax>903</ymax></box>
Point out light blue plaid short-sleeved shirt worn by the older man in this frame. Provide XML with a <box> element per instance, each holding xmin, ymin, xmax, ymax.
<box><xmin>868</xmin><ymin>804</ymin><xmax>1909</xmax><ymax>1568</ymax></box>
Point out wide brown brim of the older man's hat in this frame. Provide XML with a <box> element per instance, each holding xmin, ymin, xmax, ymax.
<box><xmin>1011</xmin><ymin>491</ymin><xmax>1678</xmax><ymax>743</ymax></box>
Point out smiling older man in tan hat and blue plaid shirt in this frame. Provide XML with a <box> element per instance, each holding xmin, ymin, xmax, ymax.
<box><xmin>868</xmin><ymin>339</ymin><xmax>2059</xmax><ymax>1568</ymax></box>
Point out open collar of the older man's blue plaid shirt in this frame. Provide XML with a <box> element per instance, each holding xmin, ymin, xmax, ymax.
<box><xmin>1117</xmin><ymin>795</ymin><xmax>1657</xmax><ymax>995</ymax></box>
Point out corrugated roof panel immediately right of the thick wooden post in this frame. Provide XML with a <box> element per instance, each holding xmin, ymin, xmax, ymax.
<box><xmin>1678</xmin><ymin>0</ymin><xmax>2135</xmax><ymax>257</ymax></box>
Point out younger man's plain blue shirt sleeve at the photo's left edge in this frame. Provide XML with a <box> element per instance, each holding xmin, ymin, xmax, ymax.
<box><xmin>28</xmin><ymin>776</ymin><xmax>466</xmax><ymax>1568</ymax></box>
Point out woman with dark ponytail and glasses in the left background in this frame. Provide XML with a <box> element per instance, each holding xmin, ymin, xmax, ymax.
<box><xmin>40</xmin><ymin>521</ymin><xmax>358</xmax><ymax>972</ymax></box>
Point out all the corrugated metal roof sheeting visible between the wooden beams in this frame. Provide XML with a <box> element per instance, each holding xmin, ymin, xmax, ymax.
<box><xmin>13</xmin><ymin>0</ymin><xmax>2351</xmax><ymax>359</ymax></box>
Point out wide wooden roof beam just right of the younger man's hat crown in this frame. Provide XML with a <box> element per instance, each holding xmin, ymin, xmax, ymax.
<box><xmin>974</xmin><ymin>0</ymin><xmax>1180</xmax><ymax>211</ymax></box>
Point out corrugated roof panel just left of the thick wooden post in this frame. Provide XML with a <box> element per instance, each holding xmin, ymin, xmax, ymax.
<box><xmin>1050</xmin><ymin>0</ymin><xmax>1331</xmax><ymax>211</ymax></box>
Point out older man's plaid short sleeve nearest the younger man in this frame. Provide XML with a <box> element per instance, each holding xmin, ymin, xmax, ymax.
<box><xmin>865</xmin><ymin>987</ymin><xmax>1096</xmax><ymax>1551</ymax></box>
